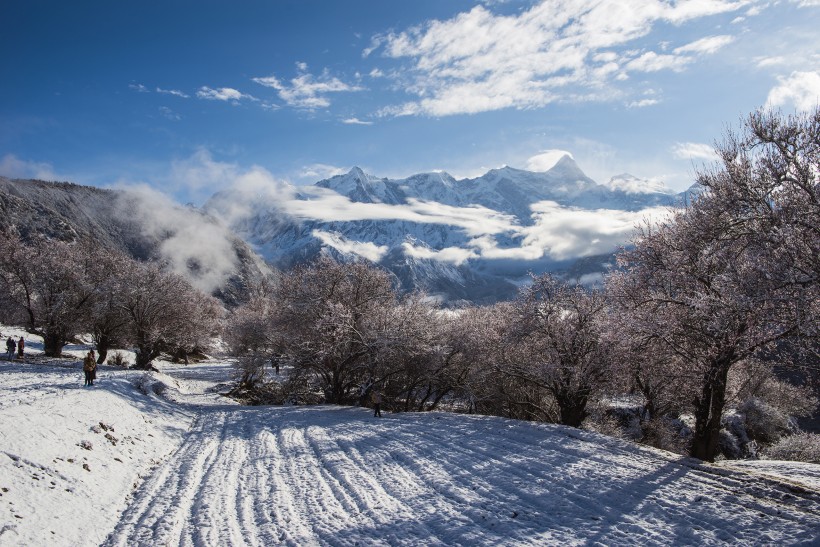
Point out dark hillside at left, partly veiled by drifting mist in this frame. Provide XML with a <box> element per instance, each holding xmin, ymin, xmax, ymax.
<box><xmin>0</xmin><ymin>177</ymin><xmax>268</xmax><ymax>305</ymax></box>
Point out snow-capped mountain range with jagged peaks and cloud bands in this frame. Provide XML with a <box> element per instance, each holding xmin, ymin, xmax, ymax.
<box><xmin>205</xmin><ymin>155</ymin><xmax>680</xmax><ymax>302</ymax></box>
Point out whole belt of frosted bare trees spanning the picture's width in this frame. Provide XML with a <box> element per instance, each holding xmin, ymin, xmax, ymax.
<box><xmin>0</xmin><ymin>109</ymin><xmax>820</xmax><ymax>460</ymax></box>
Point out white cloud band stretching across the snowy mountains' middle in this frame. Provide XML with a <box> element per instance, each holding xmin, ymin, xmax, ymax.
<box><xmin>206</xmin><ymin>159</ymin><xmax>669</xmax><ymax>266</ymax></box>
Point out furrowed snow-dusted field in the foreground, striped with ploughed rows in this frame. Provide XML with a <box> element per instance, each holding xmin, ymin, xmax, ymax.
<box><xmin>107</xmin><ymin>400</ymin><xmax>820</xmax><ymax>546</ymax></box>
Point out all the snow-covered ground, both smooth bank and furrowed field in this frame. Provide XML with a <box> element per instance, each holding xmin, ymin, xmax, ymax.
<box><xmin>0</xmin><ymin>328</ymin><xmax>820</xmax><ymax>546</ymax></box>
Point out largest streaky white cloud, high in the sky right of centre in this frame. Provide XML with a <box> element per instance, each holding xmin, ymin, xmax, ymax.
<box><xmin>374</xmin><ymin>0</ymin><xmax>747</xmax><ymax>116</ymax></box>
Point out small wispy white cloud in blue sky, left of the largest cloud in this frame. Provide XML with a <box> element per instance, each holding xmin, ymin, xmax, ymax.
<box><xmin>253</xmin><ymin>63</ymin><xmax>362</xmax><ymax>110</ymax></box>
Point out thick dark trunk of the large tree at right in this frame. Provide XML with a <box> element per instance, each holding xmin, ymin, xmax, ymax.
<box><xmin>689</xmin><ymin>358</ymin><xmax>732</xmax><ymax>462</ymax></box>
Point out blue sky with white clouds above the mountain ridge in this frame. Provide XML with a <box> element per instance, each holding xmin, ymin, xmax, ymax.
<box><xmin>0</xmin><ymin>0</ymin><xmax>820</xmax><ymax>203</ymax></box>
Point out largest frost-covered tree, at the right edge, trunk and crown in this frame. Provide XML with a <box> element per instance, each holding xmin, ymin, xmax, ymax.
<box><xmin>609</xmin><ymin>110</ymin><xmax>820</xmax><ymax>460</ymax></box>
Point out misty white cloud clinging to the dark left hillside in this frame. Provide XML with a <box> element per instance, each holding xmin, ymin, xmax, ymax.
<box><xmin>118</xmin><ymin>185</ymin><xmax>237</xmax><ymax>293</ymax></box>
